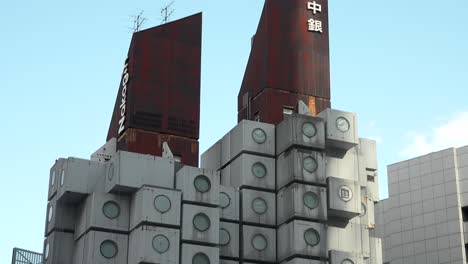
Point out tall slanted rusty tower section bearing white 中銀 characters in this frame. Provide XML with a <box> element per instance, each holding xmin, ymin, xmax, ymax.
<box><xmin>238</xmin><ymin>0</ymin><xmax>330</xmax><ymax>123</ymax></box>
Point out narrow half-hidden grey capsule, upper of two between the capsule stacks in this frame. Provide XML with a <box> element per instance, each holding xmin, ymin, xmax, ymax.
<box><xmin>219</xmin><ymin>185</ymin><xmax>240</xmax><ymax>222</ymax></box>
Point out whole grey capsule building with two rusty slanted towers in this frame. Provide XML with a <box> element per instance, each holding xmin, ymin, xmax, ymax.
<box><xmin>44</xmin><ymin>0</ymin><xmax>382</xmax><ymax>264</ymax></box>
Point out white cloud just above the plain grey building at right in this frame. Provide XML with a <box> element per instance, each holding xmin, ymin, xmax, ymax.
<box><xmin>400</xmin><ymin>112</ymin><xmax>468</xmax><ymax>158</ymax></box>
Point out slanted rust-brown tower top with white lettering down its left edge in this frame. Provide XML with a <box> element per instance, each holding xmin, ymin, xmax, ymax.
<box><xmin>107</xmin><ymin>13</ymin><xmax>202</xmax><ymax>140</ymax></box>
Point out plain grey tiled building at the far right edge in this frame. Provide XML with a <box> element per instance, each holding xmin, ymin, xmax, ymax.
<box><xmin>375</xmin><ymin>146</ymin><xmax>468</xmax><ymax>264</ymax></box>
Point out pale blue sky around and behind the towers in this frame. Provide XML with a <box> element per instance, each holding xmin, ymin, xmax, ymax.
<box><xmin>0</xmin><ymin>0</ymin><xmax>468</xmax><ymax>263</ymax></box>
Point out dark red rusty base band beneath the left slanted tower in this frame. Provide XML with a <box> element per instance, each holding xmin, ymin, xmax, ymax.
<box><xmin>117</xmin><ymin>128</ymin><xmax>198</xmax><ymax>167</ymax></box>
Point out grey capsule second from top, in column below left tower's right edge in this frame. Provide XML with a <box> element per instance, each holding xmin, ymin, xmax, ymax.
<box><xmin>182</xmin><ymin>204</ymin><xmax>219</xmax><ymax>246</ymax></box>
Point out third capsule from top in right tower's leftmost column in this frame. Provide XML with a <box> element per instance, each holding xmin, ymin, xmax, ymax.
<box><xmin>241</xmin><ymin>189</ymin><xmax>276</xmax><ymax>227</ymax></box>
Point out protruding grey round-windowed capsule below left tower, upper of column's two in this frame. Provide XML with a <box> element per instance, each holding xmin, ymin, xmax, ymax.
<box><xmin>130</xmin><ymin>186</ymin><xmax>182</xmax><ymax>230</ymax></box>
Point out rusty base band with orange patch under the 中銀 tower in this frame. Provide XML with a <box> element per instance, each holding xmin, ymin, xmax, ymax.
<box><xmin>238</xmin><ymin>88</ymin><xmax>330</xmax><ymax>125</ymax></box>
